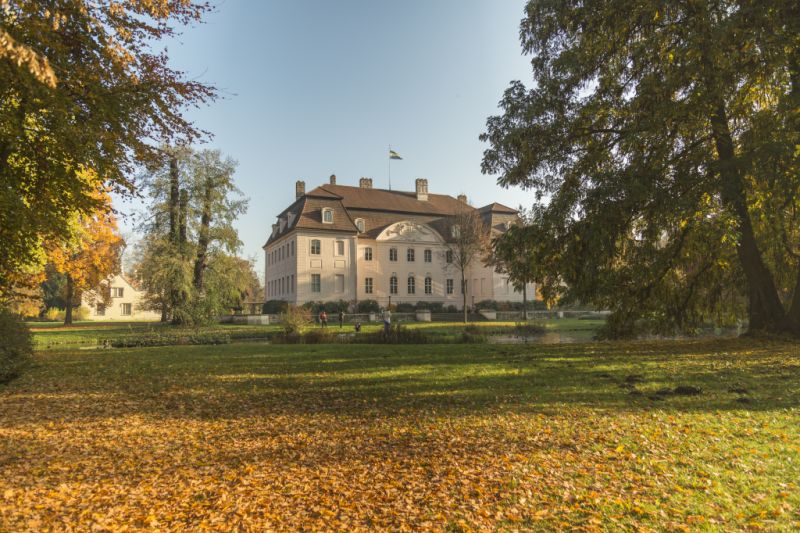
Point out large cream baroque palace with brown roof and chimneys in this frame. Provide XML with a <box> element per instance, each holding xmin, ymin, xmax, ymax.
<box><xmin>264</xmin><ymin>176</ymin><xmax>533</xmax><ymax>308</ymax></box>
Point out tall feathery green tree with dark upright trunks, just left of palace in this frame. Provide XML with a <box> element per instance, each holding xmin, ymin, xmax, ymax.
<box><xmin>136</xmin><ymin>147</ymin><xmax>250</xmax><ymax>324</ymax></box>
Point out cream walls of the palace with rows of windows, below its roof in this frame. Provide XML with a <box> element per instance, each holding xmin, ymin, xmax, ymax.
<box><xmin>264</xmin><ymin>220</ymin><xmax>533</xmax><ymax>308</ymax></box>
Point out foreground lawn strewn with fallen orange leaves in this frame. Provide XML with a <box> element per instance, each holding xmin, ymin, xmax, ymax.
<box><xmin>0</xmin><ymin>339</ymin><xmax>800</xmax><ymax>531</ymax></box>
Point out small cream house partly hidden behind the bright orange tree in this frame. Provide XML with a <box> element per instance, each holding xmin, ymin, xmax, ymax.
<box><xmin>81</xmin><ymin>274</ymin><xmax>161</xmax><ymax>322</ymax></box>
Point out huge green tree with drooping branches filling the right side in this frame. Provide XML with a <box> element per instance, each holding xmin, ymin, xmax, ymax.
<box><xmin>481</xmin><ymin>0</ymin><xmax>800</xmax><ymax>335</ymax></box>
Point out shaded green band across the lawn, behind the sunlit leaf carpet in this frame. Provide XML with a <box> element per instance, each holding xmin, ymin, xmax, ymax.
<box><xmin>0</xmin><ymin>340</ymin><xmax>800</xmax><ymax>420</ymax></box>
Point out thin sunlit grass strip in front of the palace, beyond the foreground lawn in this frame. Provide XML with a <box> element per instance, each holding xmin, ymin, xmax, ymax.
<box><xmin>30</xmin><ymin>318</ymin><xmax>603</xmax><ymax>350</ymax></box>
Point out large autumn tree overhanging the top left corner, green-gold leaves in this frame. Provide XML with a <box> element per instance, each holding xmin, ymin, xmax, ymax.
<box><xmin>0</xmin><ymin>0</ymin><xmax>214</xmax><ymax>297</ymax></box>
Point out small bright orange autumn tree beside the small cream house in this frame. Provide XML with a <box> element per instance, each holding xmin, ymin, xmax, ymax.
<box><xmin>49</xmin><ymin>195</ymin><xmax>124</xmax><ymax>325</ymax></box>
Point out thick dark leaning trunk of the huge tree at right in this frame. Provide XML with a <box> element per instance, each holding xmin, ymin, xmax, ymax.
<box><xmin>711</xmin><ymin>101</ymin><xmax>785</xmax><ymax>331</ymax></box>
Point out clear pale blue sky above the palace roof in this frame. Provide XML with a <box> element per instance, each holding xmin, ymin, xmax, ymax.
<box><xmin>119</xmin><ymin>0</ymin><xmax>532</xmax><ymax>272</ymax></box>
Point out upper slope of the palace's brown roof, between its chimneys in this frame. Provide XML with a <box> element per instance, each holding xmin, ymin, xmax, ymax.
<box><xmin>308</xmin><ymin>185</ymin><xmax>467</xmax><ymax>215</ymax></box>
